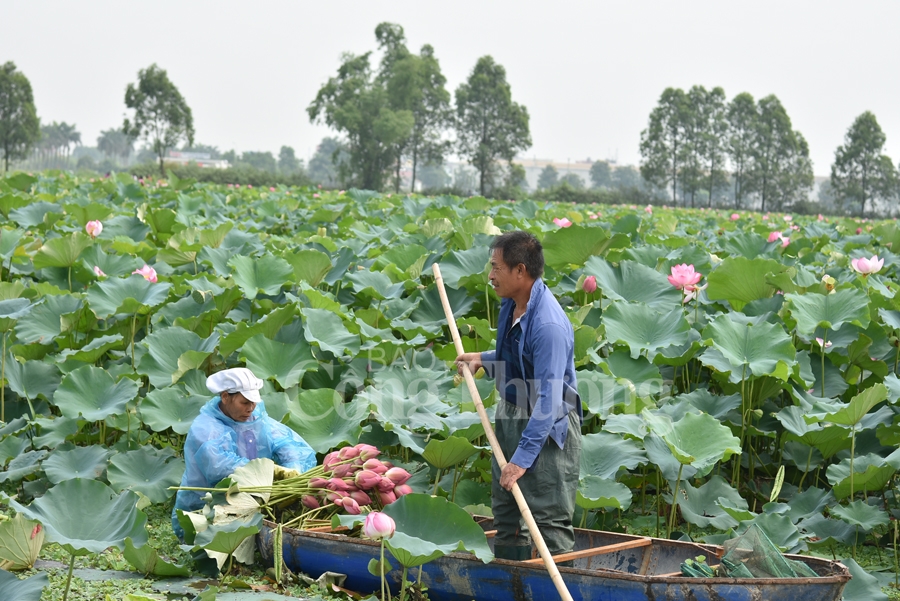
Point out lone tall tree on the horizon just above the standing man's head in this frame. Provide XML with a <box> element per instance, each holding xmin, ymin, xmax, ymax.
<box><xmin>456</xmin><ymin>56</ymin><xmax>531</xmax><ymax>195</ymax></box>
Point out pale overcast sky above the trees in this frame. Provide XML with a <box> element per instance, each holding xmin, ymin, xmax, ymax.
<box><xmin>0</xmin><ymin>0</ymin><xmax>900</xmax><ymax>175</ymax></box>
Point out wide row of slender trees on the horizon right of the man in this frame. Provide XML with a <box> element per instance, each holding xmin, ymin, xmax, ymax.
<box><xmin>640</xmin><ymin>86</ymin><xmax>813</xmax><ymax>211</ymax></box>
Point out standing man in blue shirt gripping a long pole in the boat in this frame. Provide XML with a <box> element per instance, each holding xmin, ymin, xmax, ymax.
<box><xmin>456</xmin><ymin>231</ymin><xmax>582</xmax><ymax>560</ymax></box>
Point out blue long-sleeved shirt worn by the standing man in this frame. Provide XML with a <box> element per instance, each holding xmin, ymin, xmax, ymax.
<box><xmin>481</xmin><ymin>279</ymin><xmax>582</xmax><ymax>469</ymax></box>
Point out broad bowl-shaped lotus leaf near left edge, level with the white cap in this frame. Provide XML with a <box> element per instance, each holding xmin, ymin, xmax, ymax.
<box><xmin>51</xmin><ymin>365</ymin><xmax>139</xmax><ymax>421</ymax></box>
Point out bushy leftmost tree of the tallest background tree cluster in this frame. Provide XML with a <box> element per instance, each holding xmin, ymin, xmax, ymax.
<box><xmin>306</xmin><ymin>46</ymin><xmax>414</xmax><ymax>190</ymax></box>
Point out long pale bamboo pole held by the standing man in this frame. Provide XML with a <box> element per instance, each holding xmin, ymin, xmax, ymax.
<box><xmin>432</xmin><ymin>263</ymin><xmax>572</xmax><ymax>601</ymax></box>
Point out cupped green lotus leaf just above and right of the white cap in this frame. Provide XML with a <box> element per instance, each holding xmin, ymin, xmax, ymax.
<box><xmin>240</xmin><ymin>334</ymin><xmax>318</xmax><ymax>388</ymax></box>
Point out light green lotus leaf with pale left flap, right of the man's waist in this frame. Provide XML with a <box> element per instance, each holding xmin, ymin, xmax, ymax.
<box><xmin>641</xmin><ymin>409</ymin><xmax>741</xmax><ymax>471</ymax></box>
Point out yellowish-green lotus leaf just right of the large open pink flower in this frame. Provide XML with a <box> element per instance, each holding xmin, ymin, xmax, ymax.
<box><xmin>706</xmin><ymin>257</ymin><xmax>787</xmax><ymax>311</ymax></box>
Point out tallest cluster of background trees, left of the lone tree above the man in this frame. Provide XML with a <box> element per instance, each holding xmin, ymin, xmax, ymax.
<box><xmin>307</xmin><ymin>23</ymin><xmax>531</xmax><ymax>194</ymax></box>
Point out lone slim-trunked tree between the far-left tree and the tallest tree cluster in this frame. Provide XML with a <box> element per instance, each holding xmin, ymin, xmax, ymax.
<box><xmin>122</xmin><ymin>63</ymin><xmax>194</xmax><ymax>175</ymax></box>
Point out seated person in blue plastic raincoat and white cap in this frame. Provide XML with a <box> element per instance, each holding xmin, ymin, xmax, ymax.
<box><xmin>172</xmin><ymin>367</ymin><xmax>316</xmax><ymax>539</ymax></box>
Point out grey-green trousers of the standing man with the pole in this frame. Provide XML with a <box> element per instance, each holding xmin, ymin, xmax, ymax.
<box><xmin>491</xmin><ymin>401</ymin><xmax>581</xmax><ymax>560</ymax></box>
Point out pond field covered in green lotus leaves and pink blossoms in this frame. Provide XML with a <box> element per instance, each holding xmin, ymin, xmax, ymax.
<box><xmin>0</xmin><ymin>173</ymin><xmax>900</xmax><ymax>598</ymax></box>
